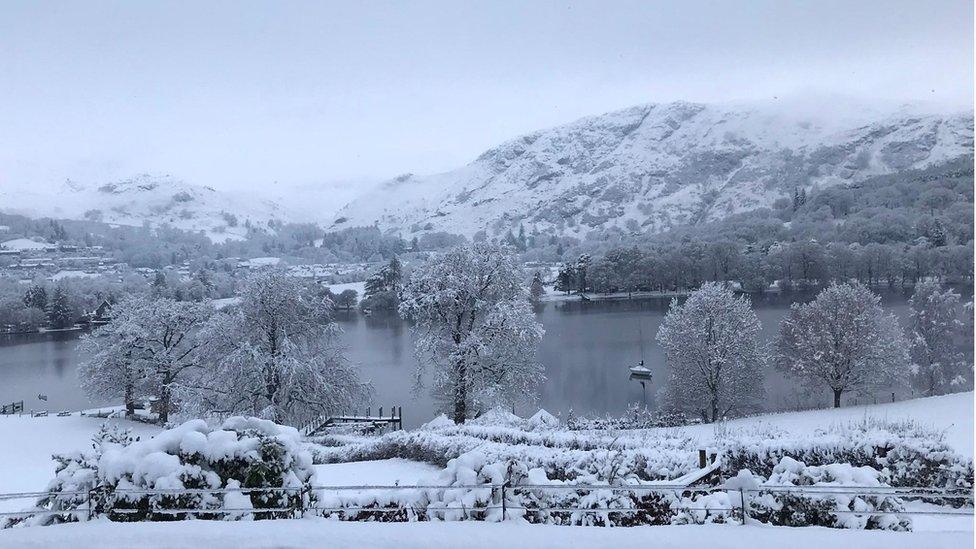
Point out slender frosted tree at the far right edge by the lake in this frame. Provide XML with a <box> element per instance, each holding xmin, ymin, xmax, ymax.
<box><xmin>908</xmin><ymin>281</ymin><xmax>967</xmax><ymax>395</ymax></box>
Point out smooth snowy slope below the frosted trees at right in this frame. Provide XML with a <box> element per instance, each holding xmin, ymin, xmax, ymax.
<box><xmin>681</xmin><ymin>391</ymin><xmax>974</xmax><ymax>457</ymax></box>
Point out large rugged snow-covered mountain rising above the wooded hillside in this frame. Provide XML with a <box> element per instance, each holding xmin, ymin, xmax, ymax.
<box><xmin>332</xmin><ymin>102</ymin><xmax>973</xmax><ymax>236</ymax></box>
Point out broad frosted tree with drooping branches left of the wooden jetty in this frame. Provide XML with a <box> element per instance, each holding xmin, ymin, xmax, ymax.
<box><xmin>186</xmin><ymin>270</ymin><xmax>369</xmax><ymax>425</ymax></box>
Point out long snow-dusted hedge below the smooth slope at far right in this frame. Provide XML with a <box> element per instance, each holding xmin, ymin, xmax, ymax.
<box><xmin>721</xmin><ymin>421</ymin><xmax>973</xmax><ymax>489</ymax></box>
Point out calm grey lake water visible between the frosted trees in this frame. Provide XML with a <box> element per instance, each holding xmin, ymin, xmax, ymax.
<box><xmin>0</xmin><ymin>293</ymin><xmax>936</xmax><ymax>426</ymax></box>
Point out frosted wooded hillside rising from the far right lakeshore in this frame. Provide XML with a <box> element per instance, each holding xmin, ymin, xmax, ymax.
<box><xmin>560</xmin><ymin>161</ymin><xmax>973</xmax><ymax>292</ymax></box>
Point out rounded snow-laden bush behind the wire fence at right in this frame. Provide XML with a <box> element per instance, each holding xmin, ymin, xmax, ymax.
<box><xmin>725</xmin><ymin>457</ymin><xmax>911</xmax><ymax>530</ymax></box>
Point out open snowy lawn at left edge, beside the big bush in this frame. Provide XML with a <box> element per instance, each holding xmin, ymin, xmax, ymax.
<box><xmin>0</xmin><ymin>415</ymin><xmax>159</xmax><ymax>494</ymax></box>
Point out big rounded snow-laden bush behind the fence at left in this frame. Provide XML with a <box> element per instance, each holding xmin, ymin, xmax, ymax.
<box><xmin>3</xmin><ymin>417</ymin><xmax>313</xmax><ymax>524</ymax></box>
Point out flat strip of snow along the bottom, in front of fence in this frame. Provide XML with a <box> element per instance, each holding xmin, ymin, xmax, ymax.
<box><xmin>0</xmin><ymin>518</ymin><xmax>973</xmax><ymax>549</ymax></box>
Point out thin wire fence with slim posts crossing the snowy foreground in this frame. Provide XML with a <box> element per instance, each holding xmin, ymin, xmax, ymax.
<box><xmin>0</xmin><ymin>482</ymin><xmax>973</xmax><ymax>524</ymax></box>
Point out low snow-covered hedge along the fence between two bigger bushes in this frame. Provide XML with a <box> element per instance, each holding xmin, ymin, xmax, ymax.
<box><xmin>315</xmin><ymin>450</ymin><xmax>735</xmax><ymax>526</ymax></box>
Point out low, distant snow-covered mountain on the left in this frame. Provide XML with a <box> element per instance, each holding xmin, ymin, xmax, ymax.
<box><xmin>0</xmin><ymin>174</ymin><xmax>291</xmax><ymax>242</ymax></box>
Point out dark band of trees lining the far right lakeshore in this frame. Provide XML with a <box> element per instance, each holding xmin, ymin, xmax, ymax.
<box><xmin>556</xmin><ymin>240</ymin><xmax>973</xmax><ymax>293</ymax></box>
